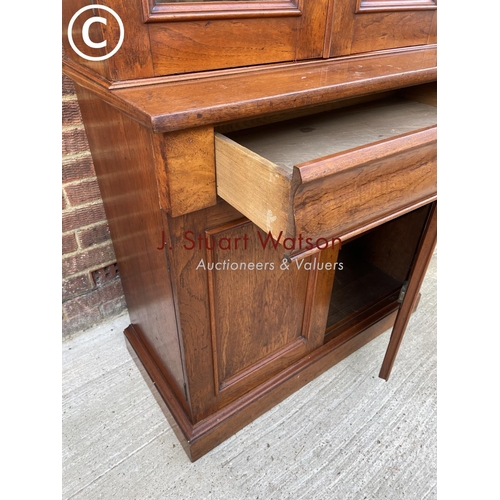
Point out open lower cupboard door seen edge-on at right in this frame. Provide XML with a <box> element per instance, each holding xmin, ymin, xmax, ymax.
<box><xmin>379</xmin><ymin>203</ymin><xmax>437</xmax><ymax>380</ymax></box>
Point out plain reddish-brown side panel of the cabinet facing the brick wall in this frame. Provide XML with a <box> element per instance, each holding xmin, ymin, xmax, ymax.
<box><xmin>76</xmin><ymin>86</ymin><xmax>187</xmax><ymax>410</ymax></box>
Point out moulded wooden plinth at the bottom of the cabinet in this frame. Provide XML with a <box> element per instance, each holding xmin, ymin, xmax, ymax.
<box><xmin>124</xmin><ymin>307</ymin><xmax>397</xmax><ymax>462</ymax></box>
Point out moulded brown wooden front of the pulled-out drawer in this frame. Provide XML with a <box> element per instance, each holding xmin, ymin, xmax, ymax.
<box><xmin>292</xmin><ymin>127</ymin><xmax>437</xmax><ymax>239</ymax></box>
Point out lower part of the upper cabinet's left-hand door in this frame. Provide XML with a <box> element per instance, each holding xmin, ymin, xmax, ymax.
<box><xmin>144</xmin><ymin>0</ymin><xmax>328</xmax><ymax>76</ymax></box>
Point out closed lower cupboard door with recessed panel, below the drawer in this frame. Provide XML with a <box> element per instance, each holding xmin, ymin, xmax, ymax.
<box><xmin>205</xmin><ymin>219</ymin><xmax>338</xmax><ymax>404</ymax></box>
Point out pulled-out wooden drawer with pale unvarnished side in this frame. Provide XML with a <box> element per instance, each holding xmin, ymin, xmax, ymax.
<box><xmin>215</xmin><ymin>97</ymin><xmax>437</xmax><ymax>248</ymax></box>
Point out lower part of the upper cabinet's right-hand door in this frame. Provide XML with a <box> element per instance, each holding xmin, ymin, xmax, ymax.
<box><xmin>330</xmin><ymin>0</ymin><xmax>437</xmax><ymax>57</ymax></box>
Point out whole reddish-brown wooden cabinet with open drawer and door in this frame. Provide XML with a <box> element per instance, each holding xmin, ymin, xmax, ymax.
<box><xmin>63</xmin><ymin>0</ymin><xmax>437</xmax><ymax>460</ymax></box>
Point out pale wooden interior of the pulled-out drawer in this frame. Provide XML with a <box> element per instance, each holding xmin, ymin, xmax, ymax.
<box><xmin>226</xmin><ymin>96</ymin><xmax>437</xmax><ymax>176</ymax></box>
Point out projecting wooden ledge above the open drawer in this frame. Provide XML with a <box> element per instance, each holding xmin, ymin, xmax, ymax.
<box><xmin>65</xmin><ymin>46</ymin><xmax>437</xmax><ymax>132</ymax></box>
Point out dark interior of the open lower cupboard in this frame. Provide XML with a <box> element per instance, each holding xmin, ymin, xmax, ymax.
<box><xmin>325</xmin><ymin>205</ymin><xmax>429</xmax><ymax>342</ymax></box>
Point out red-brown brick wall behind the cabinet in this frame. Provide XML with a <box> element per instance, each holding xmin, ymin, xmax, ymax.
<box><xmin>62</xmin><ymin>76</ymin><xmax>126</xmax><ymax>335</ymax></box>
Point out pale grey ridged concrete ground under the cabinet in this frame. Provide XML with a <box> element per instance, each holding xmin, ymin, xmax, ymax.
<box><xmin>62</xmin><ymin>255</ymin><xmax>437</xmax><ymax>500</ymax></box>
